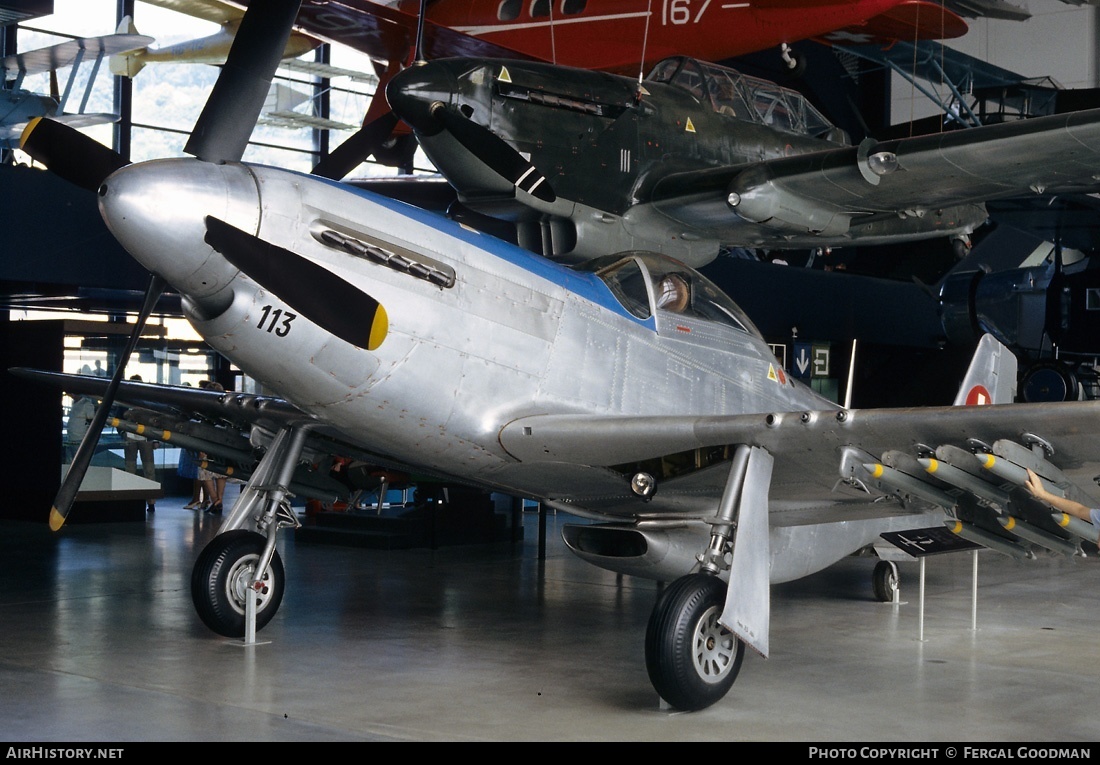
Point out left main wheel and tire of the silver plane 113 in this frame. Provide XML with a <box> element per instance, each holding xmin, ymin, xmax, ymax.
<box><xmin>191</xmin><ymin>529</ymin><xmax>286</xmax><ymax>637</ymax></box>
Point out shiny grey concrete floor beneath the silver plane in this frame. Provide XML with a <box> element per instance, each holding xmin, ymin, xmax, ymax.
<box><xmin>0</xmin><ymin>490</ymin><xmax>1100</xmax><ymax>743</ymax></box>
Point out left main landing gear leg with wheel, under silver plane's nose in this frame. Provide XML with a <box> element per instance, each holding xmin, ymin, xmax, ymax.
<box><xmin>191</xmin><ymin>425</ymin><xmax>309</xmax><ymax>637</ymax></box>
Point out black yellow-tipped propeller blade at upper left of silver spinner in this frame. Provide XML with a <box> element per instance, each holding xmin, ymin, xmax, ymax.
<box><xmin>19</xmin><ymin>117</ymin><xmax>130</xmax><ymax>192</ymax></box>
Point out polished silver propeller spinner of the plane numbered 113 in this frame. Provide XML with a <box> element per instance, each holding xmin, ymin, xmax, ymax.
<box><xmin>99</xmin><ymin>159</ymin><xmax>260</xmax><ymax>310</ymax></box>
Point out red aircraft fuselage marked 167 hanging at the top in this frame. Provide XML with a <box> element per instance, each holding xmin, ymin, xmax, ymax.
<box><xmin>397</xmin><ymin>0</ymin><xmax>967</xmax><ymax>74</ymax></box>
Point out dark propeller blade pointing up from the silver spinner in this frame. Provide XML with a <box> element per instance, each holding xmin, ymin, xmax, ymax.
<box><xmin>184</xmin><ymin>0</ymin><xmax>301</xmax><ymax>164</ymax></box>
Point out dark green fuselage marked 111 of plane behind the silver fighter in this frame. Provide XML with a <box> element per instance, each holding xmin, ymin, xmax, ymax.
<box><xmin>387</xmin><ymin>57</ymin><xmax>987</xmax><ymax>266</ymax></box>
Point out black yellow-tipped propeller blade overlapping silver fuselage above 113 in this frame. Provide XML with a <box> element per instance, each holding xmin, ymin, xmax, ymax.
<box><xmin>206</xmin><ymin>216</ymin><xmax>389</xmax><ymax>351</ymax></box>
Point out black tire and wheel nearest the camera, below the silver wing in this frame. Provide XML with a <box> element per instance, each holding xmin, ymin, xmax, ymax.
<box><xmin>646</xmin><ymin>573</ymin><xmax>745</xmax><ymax>711</ymax></box>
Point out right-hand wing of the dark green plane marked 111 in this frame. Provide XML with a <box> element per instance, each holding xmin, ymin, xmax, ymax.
<box><xmin>650</xmin><ymin>109</ymin><xmax>1100</xmax><ymax>239</ymax></box>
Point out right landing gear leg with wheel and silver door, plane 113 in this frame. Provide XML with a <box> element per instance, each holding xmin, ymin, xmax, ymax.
<box><xmin>646</xmin><ymin>446</ymin><xmax>771</xmax><ymax>711</ymax></box>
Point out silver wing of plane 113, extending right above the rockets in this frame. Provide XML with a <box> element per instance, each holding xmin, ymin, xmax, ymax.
<box><xmin>501</xmin><ymin>401</ymin><xmax>1100</xmax><ymax>514</ymax></box>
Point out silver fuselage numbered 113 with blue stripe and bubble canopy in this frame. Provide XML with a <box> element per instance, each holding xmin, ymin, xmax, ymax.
<box><xmin>100</xmin><ymin>160</ymin><xmax>834</xmax><ymax>514</ymax></box>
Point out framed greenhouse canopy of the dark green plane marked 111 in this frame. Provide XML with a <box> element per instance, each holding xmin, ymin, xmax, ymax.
<box><xmin>646</xmin><ymin>56</ymin><xmax>836</xmax><ymax>138</ymax></box>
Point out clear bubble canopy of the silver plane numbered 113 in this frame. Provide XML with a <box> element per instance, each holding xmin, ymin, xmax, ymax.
<box><xmin>590</xmin><ymin>252</ymin><xmax>761</xmax><ymax>337</ymax></box>
